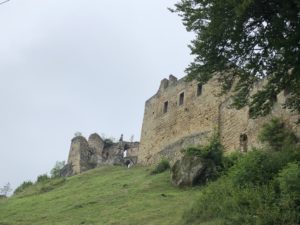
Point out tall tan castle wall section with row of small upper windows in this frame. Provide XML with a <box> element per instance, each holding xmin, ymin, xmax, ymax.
<box><xmin>139</xmin><ymin>75</ymin><xmax>226</xmax><ymax>164</ymax></box>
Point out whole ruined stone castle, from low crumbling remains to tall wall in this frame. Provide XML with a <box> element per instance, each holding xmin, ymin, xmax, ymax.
<box><xmin>62</xmin><ymin>75</ymin><xmax>300</xmax><ymax>176</ymax></box>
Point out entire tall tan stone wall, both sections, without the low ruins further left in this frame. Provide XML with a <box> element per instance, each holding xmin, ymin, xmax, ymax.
<box><xmin>138</xmin><ymin>75</ymin><xmax>300</xmax><ymax>164</ymax></box>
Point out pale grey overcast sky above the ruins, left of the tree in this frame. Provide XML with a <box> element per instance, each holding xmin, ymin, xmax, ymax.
<box><xmin>0</xmin><ymin>0</ymin><xmax>193</xmax><ymax>191</ymax></box>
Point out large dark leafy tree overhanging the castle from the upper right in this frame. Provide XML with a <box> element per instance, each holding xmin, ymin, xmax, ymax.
<box><xmin>170</xmin><ymin>0</ymin><xmax>300</xmax><ymax>118</ymax></box>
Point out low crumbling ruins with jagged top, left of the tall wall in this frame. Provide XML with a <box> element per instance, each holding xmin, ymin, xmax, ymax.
<box><xmin>61</xmin><ymin>133</ymin><xmax>139</xmax><ymax>176</ymax></box>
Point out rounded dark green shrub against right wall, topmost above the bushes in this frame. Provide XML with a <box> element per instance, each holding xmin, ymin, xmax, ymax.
<box><xmin>258</xmin><ymin>118</ymin><xmax>297</xmax><ymax>151</ymax></box>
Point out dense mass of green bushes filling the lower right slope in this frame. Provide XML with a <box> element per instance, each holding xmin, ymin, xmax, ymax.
<box><xmin>182</xmin><ymin>123</ymin><xmax>300</xmax><ymax>225</ymax></box>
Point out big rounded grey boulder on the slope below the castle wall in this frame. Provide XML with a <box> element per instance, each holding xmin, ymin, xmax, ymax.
<box><xmin>171</xmin><ymin>156</ymin><xmax>207</xmax><ymax>187</ymax></box>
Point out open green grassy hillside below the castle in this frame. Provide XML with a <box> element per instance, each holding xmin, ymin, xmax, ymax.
<box><xmin>0</xmin><ymin>167</ymin><xmax>200</xmax><ymax>225</ymax></box>
